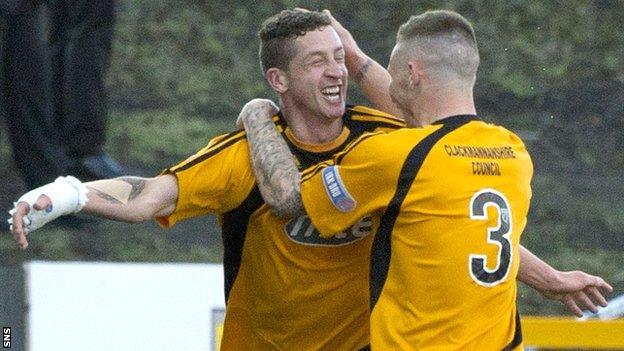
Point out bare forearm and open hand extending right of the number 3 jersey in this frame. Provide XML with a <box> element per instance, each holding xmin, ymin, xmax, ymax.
<box><xmin>518</xmin><ymin>246</ymin><xmax>613</xmax><ymax>317</ymax></box>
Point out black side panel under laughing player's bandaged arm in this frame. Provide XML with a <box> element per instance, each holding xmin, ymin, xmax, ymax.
<box><xmin>221</xmin><ymin>185</ymin><xmax>264</xmax><ymax>304</ymax></box>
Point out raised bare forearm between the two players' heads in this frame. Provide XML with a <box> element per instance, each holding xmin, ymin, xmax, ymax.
<box><xmin>323</xmin><ymin>10</ymin><xmax>401</xmax><ymax>117</ymax></box>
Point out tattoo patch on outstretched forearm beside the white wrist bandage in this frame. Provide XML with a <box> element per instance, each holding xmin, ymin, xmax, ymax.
<box><xmin>88</xmin><ymin>177</ymin><xmax>146</xmax><ymax>205</ymax></box>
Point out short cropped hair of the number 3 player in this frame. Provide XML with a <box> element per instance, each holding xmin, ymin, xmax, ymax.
<box><xmin>397</xmin><ymin>10</ymin><xmax>479</xmax><ymax>83</ymax></box>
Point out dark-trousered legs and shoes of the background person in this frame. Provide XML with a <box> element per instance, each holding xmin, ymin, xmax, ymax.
<box><xmin>0</xmin><ymin>0</ymin><xmax>123</xmax><ymax>230</ymax></box>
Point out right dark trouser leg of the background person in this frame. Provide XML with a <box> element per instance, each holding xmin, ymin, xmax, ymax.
<box><xmin>49</xmin><ymin>0</ymin><xmax>115</xmax><ymax>157</ymax></box>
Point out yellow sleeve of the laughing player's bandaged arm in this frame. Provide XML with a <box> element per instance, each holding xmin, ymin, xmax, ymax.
<box><xmin>156</xmin><ymin>131</ymin><xmax>255</xmax><ymax>227</ymax></box>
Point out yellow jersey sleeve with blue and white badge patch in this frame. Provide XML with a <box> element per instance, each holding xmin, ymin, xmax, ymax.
<box><xmin>301</xmin><ymin>133</ymin><xmax>398</xmax><ymax>237</ymax></box>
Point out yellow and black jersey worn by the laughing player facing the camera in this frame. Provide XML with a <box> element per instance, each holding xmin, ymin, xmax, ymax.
<box><xmin>157</xmin><ymin>106</ymin><xmax>404</xmax><ymax>351</ymax></box>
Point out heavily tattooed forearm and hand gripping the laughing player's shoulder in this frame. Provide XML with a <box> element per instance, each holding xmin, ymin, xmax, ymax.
<box><xmin>237</xmin><ymin>99</ymin><xmax>304</xmax><ymax>218</ymax></box>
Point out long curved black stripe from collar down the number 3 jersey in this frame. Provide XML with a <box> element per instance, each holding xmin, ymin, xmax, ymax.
<box><xmin>370</xmin><ymin>115</ymin><xmax>477</xmax><ymax>311</ymax></box>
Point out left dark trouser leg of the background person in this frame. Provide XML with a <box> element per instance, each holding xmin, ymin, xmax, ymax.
<box><xmin>0</xmin><ymin>1</ymin><xmax>72</xmax><ymax>188</ymax></box>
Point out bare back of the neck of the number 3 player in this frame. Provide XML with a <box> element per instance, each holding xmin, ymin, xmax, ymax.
<box><xmin>407</xmin><ymin>86</ymin><xmax>477</xmax><ymax>127</ymax></box>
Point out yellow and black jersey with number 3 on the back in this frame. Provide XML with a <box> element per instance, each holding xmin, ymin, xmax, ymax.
<box><xmin>301</xmin><ymin>115</ymin><xmax>533</xmax><ymax>351</ymax></box>
